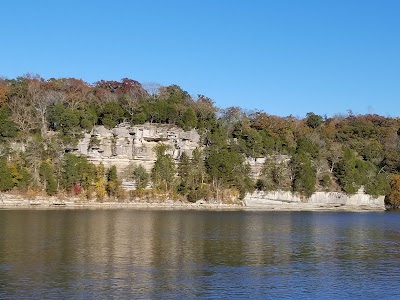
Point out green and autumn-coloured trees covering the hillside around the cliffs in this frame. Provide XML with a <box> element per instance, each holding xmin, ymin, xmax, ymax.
<box><xmin>0</xmin><ymin>75</ymin><xmax>400</xmax><ymax>207</ymax></box>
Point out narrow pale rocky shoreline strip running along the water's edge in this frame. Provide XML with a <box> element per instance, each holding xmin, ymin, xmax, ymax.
<box><xmin>0</xmin><ymin>198</ymin><xmax>385</xmax><ymax>212</ymax></box>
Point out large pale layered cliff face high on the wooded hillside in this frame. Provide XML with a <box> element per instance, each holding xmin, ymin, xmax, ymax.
<box><xmin>75</xmin><ymin>124</ymin><xmax>200</xmax><ymax>171</ymax></box>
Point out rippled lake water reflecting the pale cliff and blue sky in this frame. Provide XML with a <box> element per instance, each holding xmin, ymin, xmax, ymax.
<box><xmin>0</xmin><ymin>209</ymin><xmax>400</xmax><ymax>299</ymax></box>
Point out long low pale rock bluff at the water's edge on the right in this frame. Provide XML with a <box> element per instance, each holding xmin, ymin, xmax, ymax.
<box><xmin>243</xmin><ymin>188</ymin><xmax>385</xmax><ymax>210</ymax></box>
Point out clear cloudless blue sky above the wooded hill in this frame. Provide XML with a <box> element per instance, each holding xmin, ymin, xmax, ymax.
<box><xmin>0</xmin><ymin>0</ymin><xmax>400</xmax><ymax>117</ymax></box>
